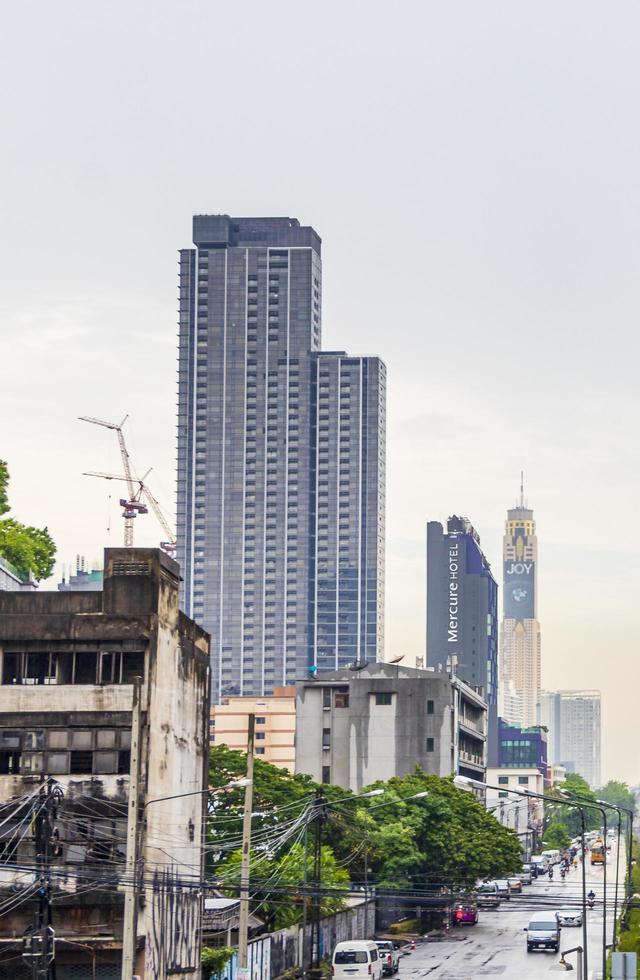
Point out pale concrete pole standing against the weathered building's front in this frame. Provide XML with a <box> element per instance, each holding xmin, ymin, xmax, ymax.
<box><xmin>122</xmin><ymin>677</ymin><xmax>142</xmax><ymax>980</ymax></box>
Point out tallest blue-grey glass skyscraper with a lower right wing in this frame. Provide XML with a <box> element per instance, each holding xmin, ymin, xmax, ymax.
<box><xmin>177</xmin><ymin>215</ymin><xmax>385</xmax><ymax>700</ymax></box>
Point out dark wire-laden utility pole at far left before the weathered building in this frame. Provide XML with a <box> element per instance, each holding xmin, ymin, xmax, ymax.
<box><xmin>22</xmin><ymin>773</ymin><xmax>62</xmax><ymax>980</ymax></box>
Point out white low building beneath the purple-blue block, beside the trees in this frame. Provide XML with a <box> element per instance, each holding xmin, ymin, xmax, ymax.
<box><xmin>485</xmin><ymin>766</ymin><xmax>545</xmax><ymax>861</ymax></box>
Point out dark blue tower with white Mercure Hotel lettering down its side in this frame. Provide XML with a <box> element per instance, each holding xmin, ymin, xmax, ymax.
<box><xmin>427</xmin><ymin>516</ymin><xmax>498</xmax><ymax>763</ymax></box>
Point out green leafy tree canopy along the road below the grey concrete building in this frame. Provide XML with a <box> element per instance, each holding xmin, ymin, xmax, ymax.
<box><xmin>208</xmin><ymin>746</ymin><xmax>522</xmax><ymax>925</ymax></box>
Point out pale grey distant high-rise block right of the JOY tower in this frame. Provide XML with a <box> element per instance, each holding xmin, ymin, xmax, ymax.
<box><xmin>538</xmin><ymin>691</ymin><xmax>602</xmax><ymax>789</ymax></box>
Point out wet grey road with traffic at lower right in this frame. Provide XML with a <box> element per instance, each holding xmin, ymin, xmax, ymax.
<box><xmin>399</xmin><ymin>848</ymin><xmax>624</xmax><ymax>980</ymax></box>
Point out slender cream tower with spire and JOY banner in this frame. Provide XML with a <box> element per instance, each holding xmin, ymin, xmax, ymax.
<box><xmin>499</xmin><ymin>483</ymin><xmax>540</xmax><ymax>728</ymax></box>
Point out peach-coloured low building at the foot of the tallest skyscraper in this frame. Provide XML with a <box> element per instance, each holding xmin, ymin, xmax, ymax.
<box><xmin>210</xmin><ymin>687</ymin><xmax>296</xmax><ymax>772</ymax></box>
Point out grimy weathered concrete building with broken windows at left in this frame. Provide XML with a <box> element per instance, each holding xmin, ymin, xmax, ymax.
<box><xmin>0</xmin><ymin>549</ymin><xmax>209</xmax><ymax>980</ymax></box>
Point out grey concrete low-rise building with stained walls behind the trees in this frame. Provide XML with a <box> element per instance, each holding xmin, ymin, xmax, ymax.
<box><xmin>296</xmin><ymin>663</ymin><xmax>487</xmax><ymax>792</ymax></box>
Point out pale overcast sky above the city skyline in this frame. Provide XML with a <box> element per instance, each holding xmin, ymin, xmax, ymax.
<box><xmin>0</xmin><ymin>0</ymin><xmax>640</xmax><ymax>783</ymax></box>
